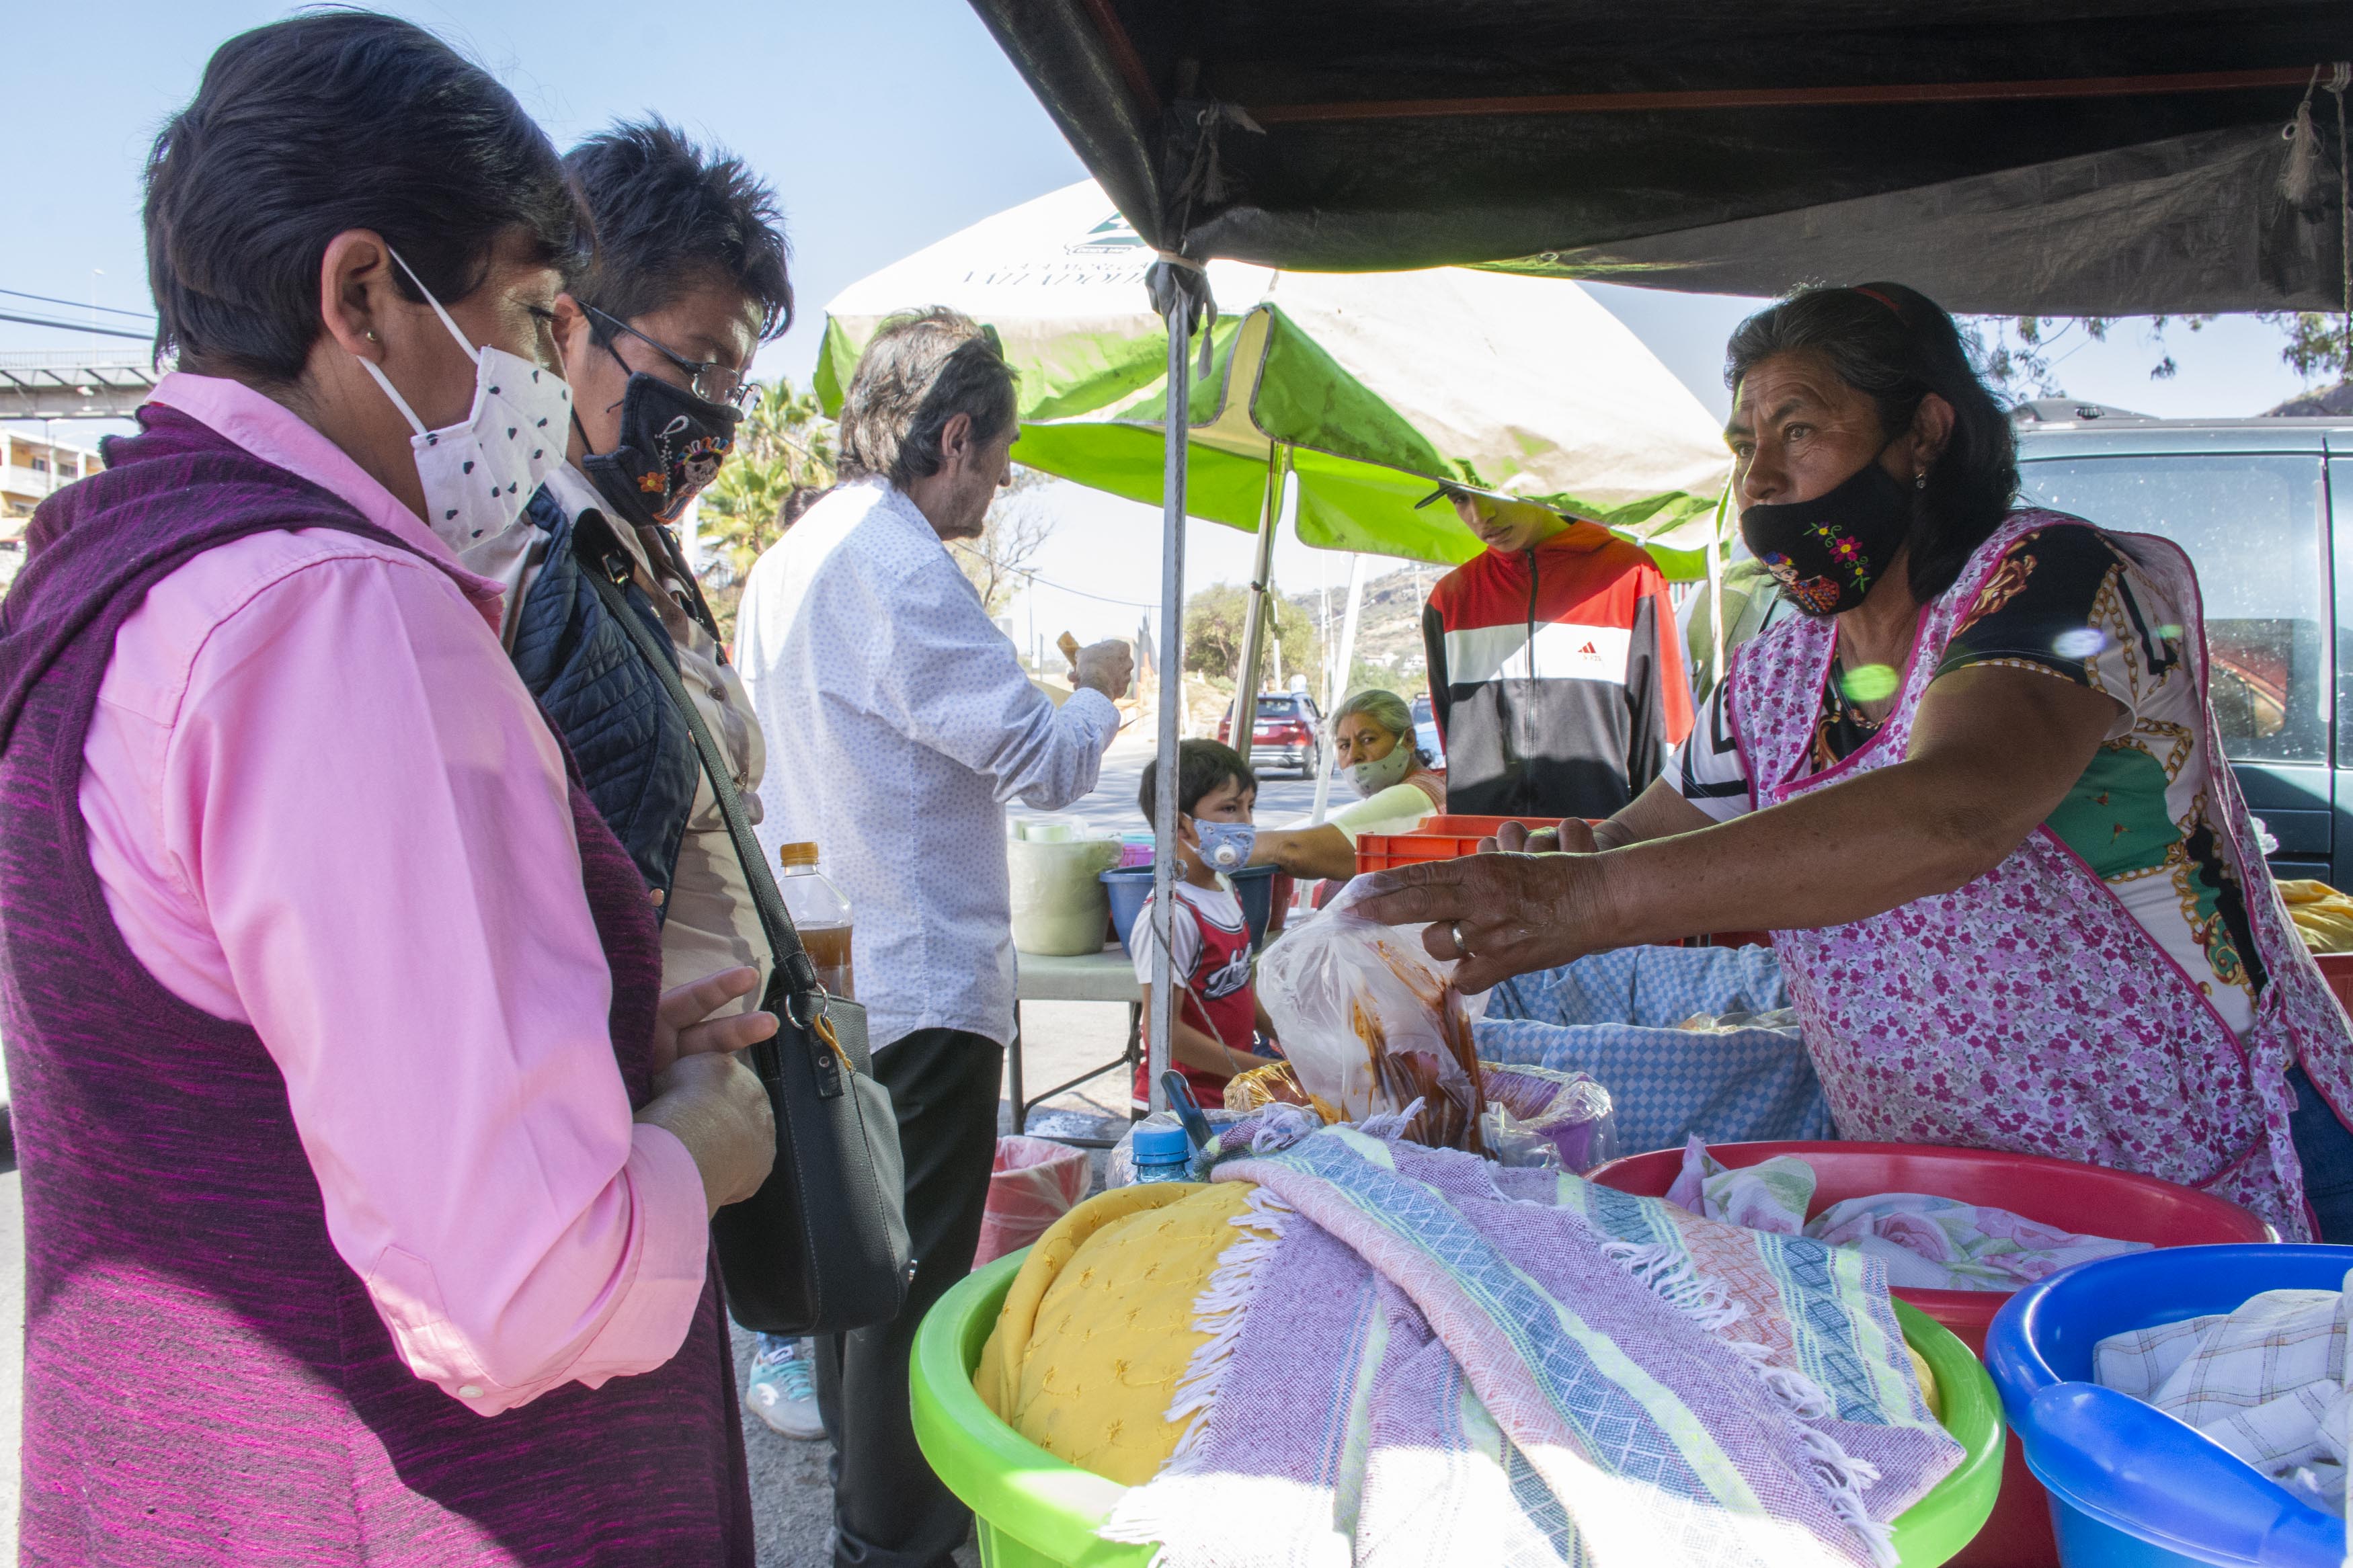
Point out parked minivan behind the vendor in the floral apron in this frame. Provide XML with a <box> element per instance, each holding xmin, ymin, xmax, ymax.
<box><xmin>2017</xmin><ymin>400</ymin><xmax>2353</xmax><ymax>886</ymax></box>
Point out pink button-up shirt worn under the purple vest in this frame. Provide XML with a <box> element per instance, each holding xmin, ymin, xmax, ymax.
<box><xmin>80</xmin><ymin>374</ymin><xmax>709</xmax><ymax>1415</ymax></box>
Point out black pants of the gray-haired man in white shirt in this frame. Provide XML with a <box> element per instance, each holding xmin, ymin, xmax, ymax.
<box><xmin>817</xmin><ymin>1030</ymin><xmax>1005</xmax><ymax>1568</ymax></box>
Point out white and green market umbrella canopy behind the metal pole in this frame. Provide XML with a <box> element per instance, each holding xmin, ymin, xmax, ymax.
<box><xmin>817</xmin><ymin>181</ymin><xmax>1730</xmax><ymax>576</ymax></box>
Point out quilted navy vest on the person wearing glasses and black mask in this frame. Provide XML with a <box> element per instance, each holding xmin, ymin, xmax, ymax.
<box><xmin>513</xmin><ymin>489</ymin><xmax>701</xmax><ymax>910</ymax></box>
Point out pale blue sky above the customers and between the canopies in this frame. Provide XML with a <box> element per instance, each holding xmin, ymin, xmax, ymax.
<box><xmin>0</xmin><ymin>0</ymin><xmax>2334</xmax><ymax>637</ymax></box>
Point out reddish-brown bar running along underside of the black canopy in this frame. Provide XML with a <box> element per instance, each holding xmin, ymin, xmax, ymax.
<box><xmin>1250</xmin><ymin>66</ymin><xmax>2325</xmax><ymax>124</ymax></box>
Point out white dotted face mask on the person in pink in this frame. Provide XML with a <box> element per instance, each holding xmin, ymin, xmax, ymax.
<box><xmin>360</xmin><ymin>247</ymin><xmax>572</xmax><ymax>550</ymax></box>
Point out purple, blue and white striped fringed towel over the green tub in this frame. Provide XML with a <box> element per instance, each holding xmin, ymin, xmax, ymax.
<box><xmin>1104</xmin><ymin>1128</ymin><xmax>1960</xmax><ymax>1568</ymax></box>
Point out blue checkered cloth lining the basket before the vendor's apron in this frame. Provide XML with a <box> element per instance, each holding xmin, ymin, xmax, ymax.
<box><xmin>1473</xmin><ymin>948</ymin><xmax>1838</xmax><ymax>1154</ymax></box>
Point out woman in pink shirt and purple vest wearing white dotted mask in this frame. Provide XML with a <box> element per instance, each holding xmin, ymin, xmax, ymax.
<box><xmin>0</xmin><ymin>11</ymin><xmax>774</xmax><ymax>1566</ymax></box>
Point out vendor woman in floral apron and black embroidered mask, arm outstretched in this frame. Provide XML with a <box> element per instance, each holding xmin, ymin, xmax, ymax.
<box><xmin>1367</xmin><ymin>284</ymin><xmax>2353</xmax><ymax>1241</ymax></box>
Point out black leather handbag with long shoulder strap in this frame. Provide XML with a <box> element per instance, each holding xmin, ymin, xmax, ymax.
<box><xmin>572</xmin><ymin>510</ymin><xmax>913</xmax><ymax>1333</ymax></box>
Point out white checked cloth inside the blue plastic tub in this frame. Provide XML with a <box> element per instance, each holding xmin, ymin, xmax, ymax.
<box><xmin>2092</xmin><ymin>1276</ymin><xmax>2353</xmax><ymax>1516</ymax></box>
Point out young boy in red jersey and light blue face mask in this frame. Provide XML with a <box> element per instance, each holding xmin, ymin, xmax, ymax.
<box><xmin>1127</xmin><ymin>741</ymin><xmax>1275</xmax><ymax>1105</ymax></box>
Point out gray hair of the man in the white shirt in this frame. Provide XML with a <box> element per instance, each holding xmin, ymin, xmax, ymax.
<box><xmin>836</xmin><ymin>306</ymin><xmax>1021</xmax><ymax>489</ymax></box>
